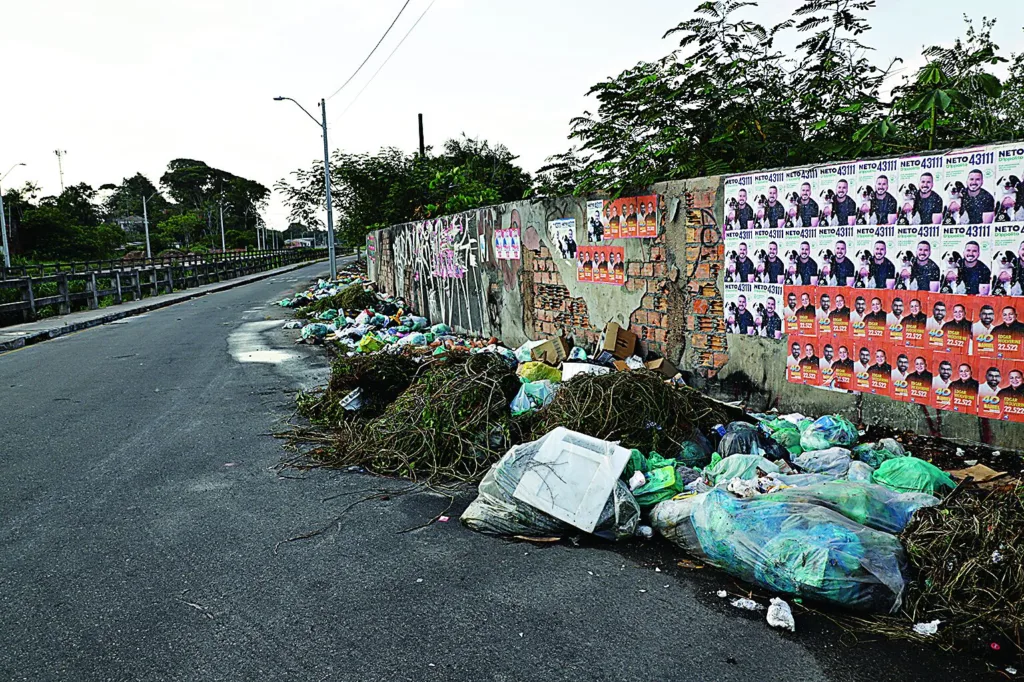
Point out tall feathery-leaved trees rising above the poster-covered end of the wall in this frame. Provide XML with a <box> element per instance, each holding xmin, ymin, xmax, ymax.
<box><xmin>538</xmin><ymin>0</ymin><xmax>1024</xmax><ymax>195</ymax></box>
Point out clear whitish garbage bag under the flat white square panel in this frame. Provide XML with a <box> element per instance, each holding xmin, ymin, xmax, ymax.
<box><xmin>461</xmin><ymin>436</ymin><xmax>640</xmax><ymax>540</ymax></box>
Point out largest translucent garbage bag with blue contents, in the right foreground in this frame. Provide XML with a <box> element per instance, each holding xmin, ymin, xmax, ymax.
<box><xmin>650</xmin><ymin>488</ymin><xmax>906</xmax><ymax>611</ymax></box>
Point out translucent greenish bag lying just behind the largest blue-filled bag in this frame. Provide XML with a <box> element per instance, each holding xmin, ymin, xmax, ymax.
<box><xmin>767</xmin><ymin>480</ymin><xmax>939</xmax><ymax>536</ymax></box>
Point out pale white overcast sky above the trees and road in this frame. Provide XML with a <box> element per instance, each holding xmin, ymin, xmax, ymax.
<box><xmin>0</xmin><ymin>0</ymin><xmax>1024</xmax><ymax>229</ymax></box>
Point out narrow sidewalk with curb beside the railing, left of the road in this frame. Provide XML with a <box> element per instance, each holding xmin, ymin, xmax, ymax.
<box><xmin>0</xmin><ymin>258</ymin><xmax>329</xmax><ymax>353</ymax></box>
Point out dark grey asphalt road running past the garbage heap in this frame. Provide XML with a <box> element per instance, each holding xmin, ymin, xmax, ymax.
<box><xmin>0</xmin><ymin>265</ymin><xmax>984</xmax><ymax>682</ymax></box>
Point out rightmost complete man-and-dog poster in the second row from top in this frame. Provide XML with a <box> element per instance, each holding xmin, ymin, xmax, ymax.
<box><xmin>939</xmin><ymin>224</ymin><xmax>993</xmax><ymax>296</ymax></box>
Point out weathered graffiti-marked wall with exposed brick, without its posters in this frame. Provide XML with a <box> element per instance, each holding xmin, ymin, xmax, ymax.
<box><xmin>367</xmin><ymin>177</ymin><xmax>1024</xmax><ymax>449</ymax></box>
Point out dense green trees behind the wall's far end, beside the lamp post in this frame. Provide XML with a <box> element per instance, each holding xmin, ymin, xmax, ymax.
<box><xmin>274</xmin><ymin>137</ymin><xmax>532</xmax><ymax>245</ymax></box>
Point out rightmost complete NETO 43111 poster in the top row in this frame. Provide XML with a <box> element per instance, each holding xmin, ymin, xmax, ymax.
<box><xmin>942</xmin><ymin>146</ymin><xmax>997</xmax><ymax>225</ymax></box>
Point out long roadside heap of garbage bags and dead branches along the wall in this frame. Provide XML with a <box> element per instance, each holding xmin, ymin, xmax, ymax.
<box><xmin>278</xmin><ymin>273</ymin><xmax>1024</xmax><ymax>643</ymax></box>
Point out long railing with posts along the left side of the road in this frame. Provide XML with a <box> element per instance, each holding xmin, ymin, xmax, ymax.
<box><xmin>0</xmin><ymin>249</ymin><xmax>324</xmax><ymax>326</ymax></box>
